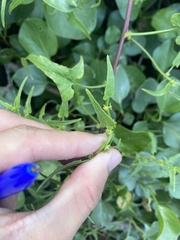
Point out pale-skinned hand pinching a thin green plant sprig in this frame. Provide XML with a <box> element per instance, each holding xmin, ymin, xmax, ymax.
<box><xmin>0</xmin><ymin>110</ymin><xmax>121</xmax><ymax>240</ymax></box>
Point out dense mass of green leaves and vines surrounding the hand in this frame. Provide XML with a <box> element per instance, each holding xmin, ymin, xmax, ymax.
<box><xmin>0</xmin><ymin>0</ymin><xmax>180</xmax><ymax>240</ymax></box>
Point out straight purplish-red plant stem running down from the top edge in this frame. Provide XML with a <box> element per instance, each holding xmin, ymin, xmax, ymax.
<box><xmin>113</xmin><ymin>0</ymin><xmax>133</xmax><ymax>72</ymax></box>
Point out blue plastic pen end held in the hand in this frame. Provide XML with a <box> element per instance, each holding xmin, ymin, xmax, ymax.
<box><xmin>0</xmin><ymin>162</ymin><xmax>40</xmax><ymax>199</ymax></box>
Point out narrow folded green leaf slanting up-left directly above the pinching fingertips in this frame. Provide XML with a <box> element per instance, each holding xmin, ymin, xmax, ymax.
<box><xmin>86</xmin><ymin>89</ymin><xmax>116</xmax><ymax>128</ymax></box>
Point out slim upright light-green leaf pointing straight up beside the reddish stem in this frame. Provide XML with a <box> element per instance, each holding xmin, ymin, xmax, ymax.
<box><xmin>103</xmin><ymin>56</ymin><xmax>115</xmax><ymax>100</ymax></box>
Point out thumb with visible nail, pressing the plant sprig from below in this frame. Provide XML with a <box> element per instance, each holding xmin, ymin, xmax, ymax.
<box><xmin>36</xmin><ymin>149</ymin><xmax>121</xmax><ymax>240</ymax></box>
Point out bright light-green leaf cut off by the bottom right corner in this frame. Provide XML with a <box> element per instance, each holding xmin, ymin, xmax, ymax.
<box><xmin>157</xmin><ymin>206</ymin><xmax>180</xmax><ymax>240</ymax></box>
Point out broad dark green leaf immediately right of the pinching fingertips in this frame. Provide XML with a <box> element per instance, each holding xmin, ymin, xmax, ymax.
<box><xmin>115</xmin><ymin>125</ymin><xmax>152</xmax><ymax>153</ymax></box>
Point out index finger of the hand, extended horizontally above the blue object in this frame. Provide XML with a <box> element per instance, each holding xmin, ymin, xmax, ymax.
<box><xmin>0</xmin><ymin>125</ymin><xmax>106</xmax><ymax>171</ymax></box>
